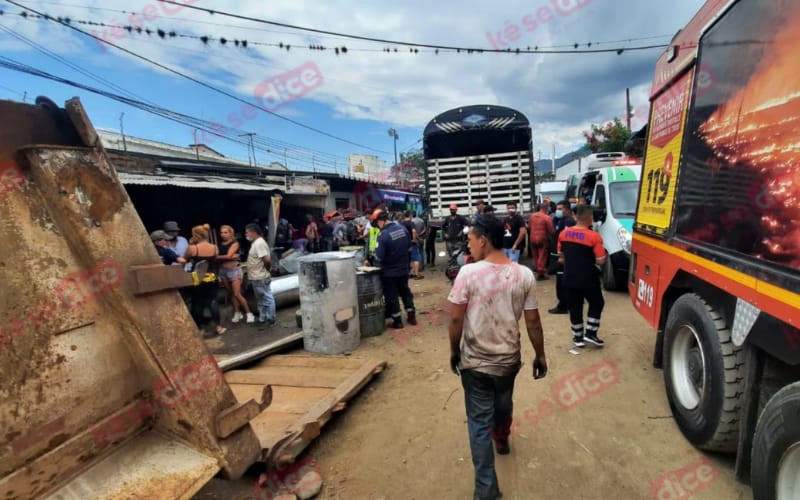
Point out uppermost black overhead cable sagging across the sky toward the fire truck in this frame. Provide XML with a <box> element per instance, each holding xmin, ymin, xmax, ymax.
<box><xmin>156</xmin><ymin>0</ymin><xmax>667</xmax><ymax>54</ymax></box>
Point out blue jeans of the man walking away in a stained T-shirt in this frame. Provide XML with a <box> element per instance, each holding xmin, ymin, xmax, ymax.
<box><xmin>461</xmin><ymin>370</ymin><xmax>517</xmax><ymax>500</ymax></box>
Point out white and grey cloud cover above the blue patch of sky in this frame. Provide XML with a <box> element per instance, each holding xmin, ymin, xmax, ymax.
<box><xmin>0</xmin><ymin>0</ymin><xmax>702</xmax><ymax>151</ymax></box>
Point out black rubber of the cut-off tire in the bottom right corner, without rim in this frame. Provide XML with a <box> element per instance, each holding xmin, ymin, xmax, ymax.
<box><xmin>750</xmin><ymin>382</ymin><xmax>800</xmax><ymax>500</ymax></box>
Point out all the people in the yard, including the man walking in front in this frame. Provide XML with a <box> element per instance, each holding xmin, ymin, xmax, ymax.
<box><xmin>145</xmin><ymin>200</ymin><xmax>606</xmax><ymax>498</ymax></box>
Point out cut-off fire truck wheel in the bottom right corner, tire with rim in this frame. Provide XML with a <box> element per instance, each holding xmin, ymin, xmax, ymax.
<box><xmin>750</xmin><ymin>382</ymin><xmax>800</xmax><ymax>500</ymax></box>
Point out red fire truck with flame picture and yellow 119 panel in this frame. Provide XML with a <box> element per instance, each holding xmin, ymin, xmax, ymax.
<box><xmin>628</xmin><ymin>0</ymin><xmax>800</xmax><ymax>499</ymax></box>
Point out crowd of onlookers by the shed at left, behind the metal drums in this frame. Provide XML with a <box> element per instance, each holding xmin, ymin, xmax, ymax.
<box><xmin>145</xmin><ymin>206</ymin><xmax>436</xmax><ymax>334</ymax></box>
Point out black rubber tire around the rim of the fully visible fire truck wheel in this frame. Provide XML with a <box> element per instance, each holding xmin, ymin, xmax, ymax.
<box><xmin>664</xmin><ymin>293</ymin><xmax>744</xmax><ymax>452</ymax></box>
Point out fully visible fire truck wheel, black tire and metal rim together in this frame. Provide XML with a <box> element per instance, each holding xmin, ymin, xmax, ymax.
<box><xmin>664</xmin><ymin>293</ymin><xmax>744</xmax><ymax>452</ymax></box>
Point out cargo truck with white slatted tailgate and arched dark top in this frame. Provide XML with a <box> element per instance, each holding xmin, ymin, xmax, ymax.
<box><xmin>423</xmin><ymin>105</ymin><xmax>534</xmax><ymax>219</ymax></box>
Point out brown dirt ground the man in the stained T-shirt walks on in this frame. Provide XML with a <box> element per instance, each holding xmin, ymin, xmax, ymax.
<box><xmin>195</xmin><ymin>254</ymin><xmax>752</xmax><ymax>500</ymax></box>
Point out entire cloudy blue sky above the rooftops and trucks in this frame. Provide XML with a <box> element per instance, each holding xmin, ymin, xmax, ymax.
<box><xmin>0</xmin><ymin>0</ymin><xmax>703</xmax><ymax>169</ymax></box>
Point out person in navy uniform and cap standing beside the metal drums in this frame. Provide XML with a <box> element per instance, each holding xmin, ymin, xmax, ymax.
<box><xmin>373</xmin><ymin>210</ymin><xmax>417</xmax><ymax>328</ymax></box>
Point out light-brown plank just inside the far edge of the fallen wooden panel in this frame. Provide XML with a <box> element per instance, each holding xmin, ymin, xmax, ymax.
<box><xmin>225</xmin><ymin>366</ymin><xmax>352</xmax><ymax>389</ymax></box>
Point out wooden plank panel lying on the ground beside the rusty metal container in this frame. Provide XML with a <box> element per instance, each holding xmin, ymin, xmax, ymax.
<box><xmin>225</xmin><ymin>353</ymin><xmax>386</xmax><ymax>468</ymax></box>
